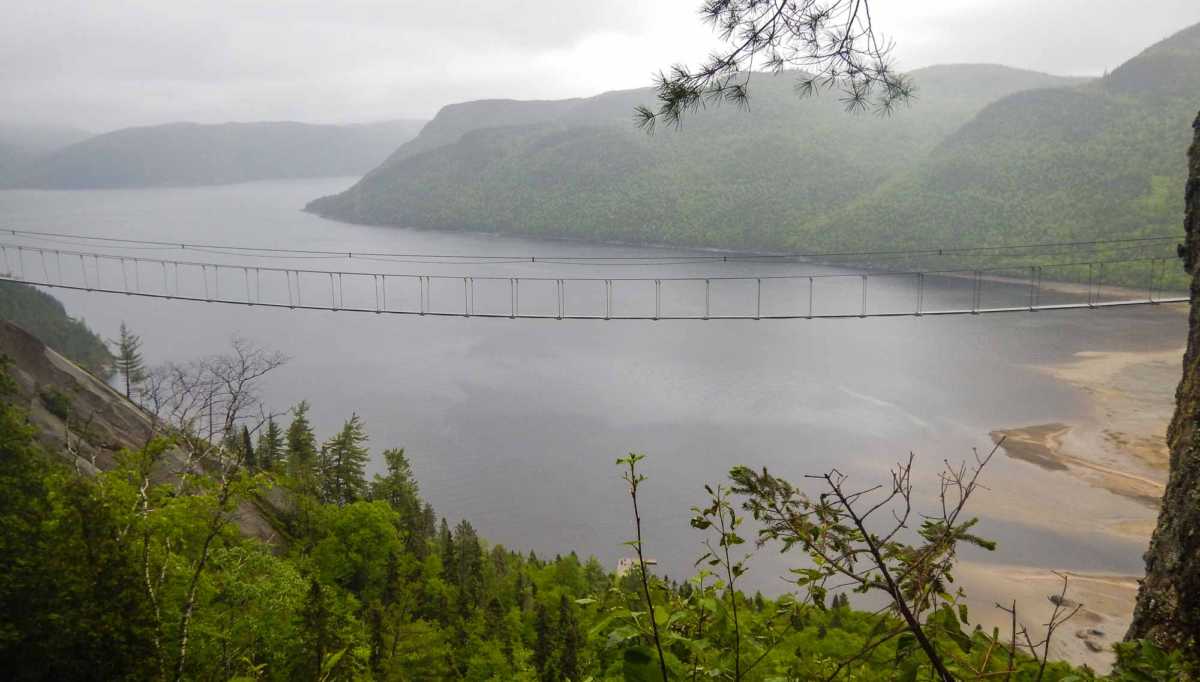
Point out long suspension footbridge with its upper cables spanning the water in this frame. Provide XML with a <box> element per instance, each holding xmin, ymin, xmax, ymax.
<box><xmin>0</xmin><ymin>231</ymin><xmax>1188</xmax><ymax>321</ymax></box>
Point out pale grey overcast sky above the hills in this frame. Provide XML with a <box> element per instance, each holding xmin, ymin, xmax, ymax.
<box><xmin>0</xmin><ymin>0</ymin><xmax>1200</xmax><ymax>131</ymax></box>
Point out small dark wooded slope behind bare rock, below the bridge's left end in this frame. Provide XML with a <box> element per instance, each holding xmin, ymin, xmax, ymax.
<box><xmin>0</xmin><ymin>282</ymin><xmax>113</xmax><ymax>377</ymax></box>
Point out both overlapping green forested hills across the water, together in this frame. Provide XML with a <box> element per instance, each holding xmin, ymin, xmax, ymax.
<box><xmin>308</xmin><ymin>26</ymin><xmax>1200</xmax><ymax>286</ymax></box>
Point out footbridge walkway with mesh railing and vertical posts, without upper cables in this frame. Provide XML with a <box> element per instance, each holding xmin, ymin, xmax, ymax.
<box><xmin>0</xmin><ymin>244</ymin><xmax>1187</xmax><ymax>319</ymax></box>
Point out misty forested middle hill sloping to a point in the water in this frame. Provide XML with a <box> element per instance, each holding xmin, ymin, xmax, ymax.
<box><xmin>308</xmin><ymin>65</ymin><xmax>1078</xmax><ymax>247</ymax></box>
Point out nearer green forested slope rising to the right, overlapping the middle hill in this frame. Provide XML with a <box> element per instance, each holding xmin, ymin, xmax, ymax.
<box><xmin>794</xmin><ymin>25</ymin><xmax>1200</xmax><ymax>266</ymax></box>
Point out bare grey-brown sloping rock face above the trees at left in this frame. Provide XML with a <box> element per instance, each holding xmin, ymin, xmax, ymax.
<box><xmin>0</xmin><ymin>321</ymin><xmax>286</xmax><ymax>544</ymax></box>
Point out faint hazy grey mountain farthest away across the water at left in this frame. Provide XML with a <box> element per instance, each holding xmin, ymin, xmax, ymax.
<box><xmin>8</xmin><ymin>120</ymin><xmax>421</xmax><ymax>189</ymax></box>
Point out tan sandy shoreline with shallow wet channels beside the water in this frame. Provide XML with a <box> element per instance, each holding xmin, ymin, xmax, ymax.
<box><xmin>960</xmin><ymin>338</ymin><xmax>1183</xmax><ymax>670</ymax></box>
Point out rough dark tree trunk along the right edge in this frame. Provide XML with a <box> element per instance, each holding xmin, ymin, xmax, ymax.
<box><xmin>1126</xmin><ymin>110</ymin><xmax>1200</xmax><ymax>663</ymax></box>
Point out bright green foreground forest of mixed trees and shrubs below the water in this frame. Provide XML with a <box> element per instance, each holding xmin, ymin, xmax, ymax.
<box><xmin>0</xmin><ymin>328</ymin><xmax>1182</xmax><ymax>681</ymax></box>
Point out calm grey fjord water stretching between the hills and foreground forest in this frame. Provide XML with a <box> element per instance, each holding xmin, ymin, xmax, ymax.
<box><xmin>0</xmin><ymin>179</ymin><xmax>1186</xmax><ymax>588</ymax></box>
